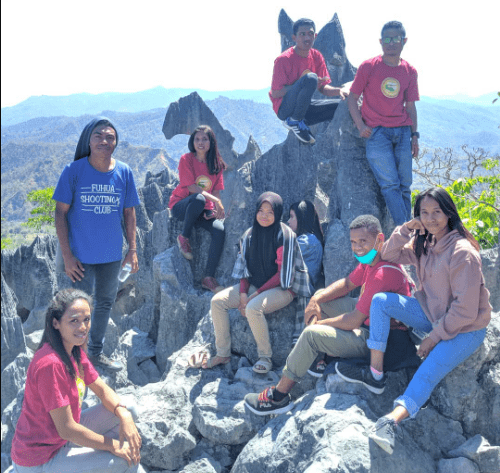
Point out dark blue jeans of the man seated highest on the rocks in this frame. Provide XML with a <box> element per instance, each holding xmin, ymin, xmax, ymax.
<box><xmin>278</xmin><ymin>72</ymin><xmax>338</xmax><ymax>125</ymax></box>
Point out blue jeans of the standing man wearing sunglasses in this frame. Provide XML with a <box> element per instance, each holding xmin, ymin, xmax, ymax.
<box><xmin>366</xmin><ymin>126</ymin><xmax>412</xmax><ymax>225</ymax></box>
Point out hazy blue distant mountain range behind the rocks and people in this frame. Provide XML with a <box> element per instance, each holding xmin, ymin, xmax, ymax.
<box><xmin>1</xmin><ymin>87</ymin><xmax>500</xmax><ymax>225</ymax></box>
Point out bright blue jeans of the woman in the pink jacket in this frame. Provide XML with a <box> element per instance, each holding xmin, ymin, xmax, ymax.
<box><xmin>366</xmin><ymin>292</ymin><xmax>486</xmax><ymax>417</ymax></box>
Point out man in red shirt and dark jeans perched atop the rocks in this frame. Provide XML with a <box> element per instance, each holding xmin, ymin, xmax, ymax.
<box><xmin>269</xmin><ymin>18</ymin><xmax>349</xmax><ymax>144</ymax></box>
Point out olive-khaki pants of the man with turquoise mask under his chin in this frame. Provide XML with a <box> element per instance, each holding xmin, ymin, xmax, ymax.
<box><xmin>283</xmin><ymin>296</ymin><xmax>370</xmax><ymax>381</ymax></box>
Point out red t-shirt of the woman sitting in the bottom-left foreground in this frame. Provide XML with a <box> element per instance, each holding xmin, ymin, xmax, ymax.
<box><xmin>11</xmin><ymin>343</ymin><xmax>99</xmax><ymax>466</ymax></box>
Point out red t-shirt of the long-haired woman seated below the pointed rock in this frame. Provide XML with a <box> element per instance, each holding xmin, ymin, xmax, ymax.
<box><xmin>168</xmin><ymin>153</ymin><xmax>224</xmax><ymax>210</ymax></box>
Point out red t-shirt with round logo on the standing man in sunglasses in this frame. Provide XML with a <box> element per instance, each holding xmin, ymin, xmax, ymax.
<box><xmin>351</xmin><ymin>56</ymin><xmax>420</xmax><ymax>128</ymax></box>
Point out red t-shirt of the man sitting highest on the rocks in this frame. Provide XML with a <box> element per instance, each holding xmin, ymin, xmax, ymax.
<box><xmin>269</xmin><ymin>48</ymin><xmax>331</xmax><ymax>113</ymax></box>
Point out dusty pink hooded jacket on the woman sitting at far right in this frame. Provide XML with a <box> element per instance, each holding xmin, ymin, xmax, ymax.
<box><xmin>382</xmin><ymin>224</ymin><xmax>492</xmax><ymax>343</ymax></box>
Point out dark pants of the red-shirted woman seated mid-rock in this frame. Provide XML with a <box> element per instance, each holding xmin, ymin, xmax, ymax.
<box><xmin>172</xmin><ymin>194</ymin><xmax>226</xmax><ymax>277</ymax></box>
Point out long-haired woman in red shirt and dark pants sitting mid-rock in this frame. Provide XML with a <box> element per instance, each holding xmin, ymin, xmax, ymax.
<box><xmin>168</xmin><ymin>125</ymin><xmax>226</xmax><ymax>292</ymax></box>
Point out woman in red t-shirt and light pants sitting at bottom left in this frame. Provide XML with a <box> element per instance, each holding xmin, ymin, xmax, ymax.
<box><xmin>11</xmin><ymin>288</ymin><xmax>144</xmax><ymax>473</ymax></box>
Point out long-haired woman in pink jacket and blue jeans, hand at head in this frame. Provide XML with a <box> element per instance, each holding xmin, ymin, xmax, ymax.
<box><xmin>336</xmin><ymin>187</ymin><xmax>491</xmax><ymax>453</ymax></box>
